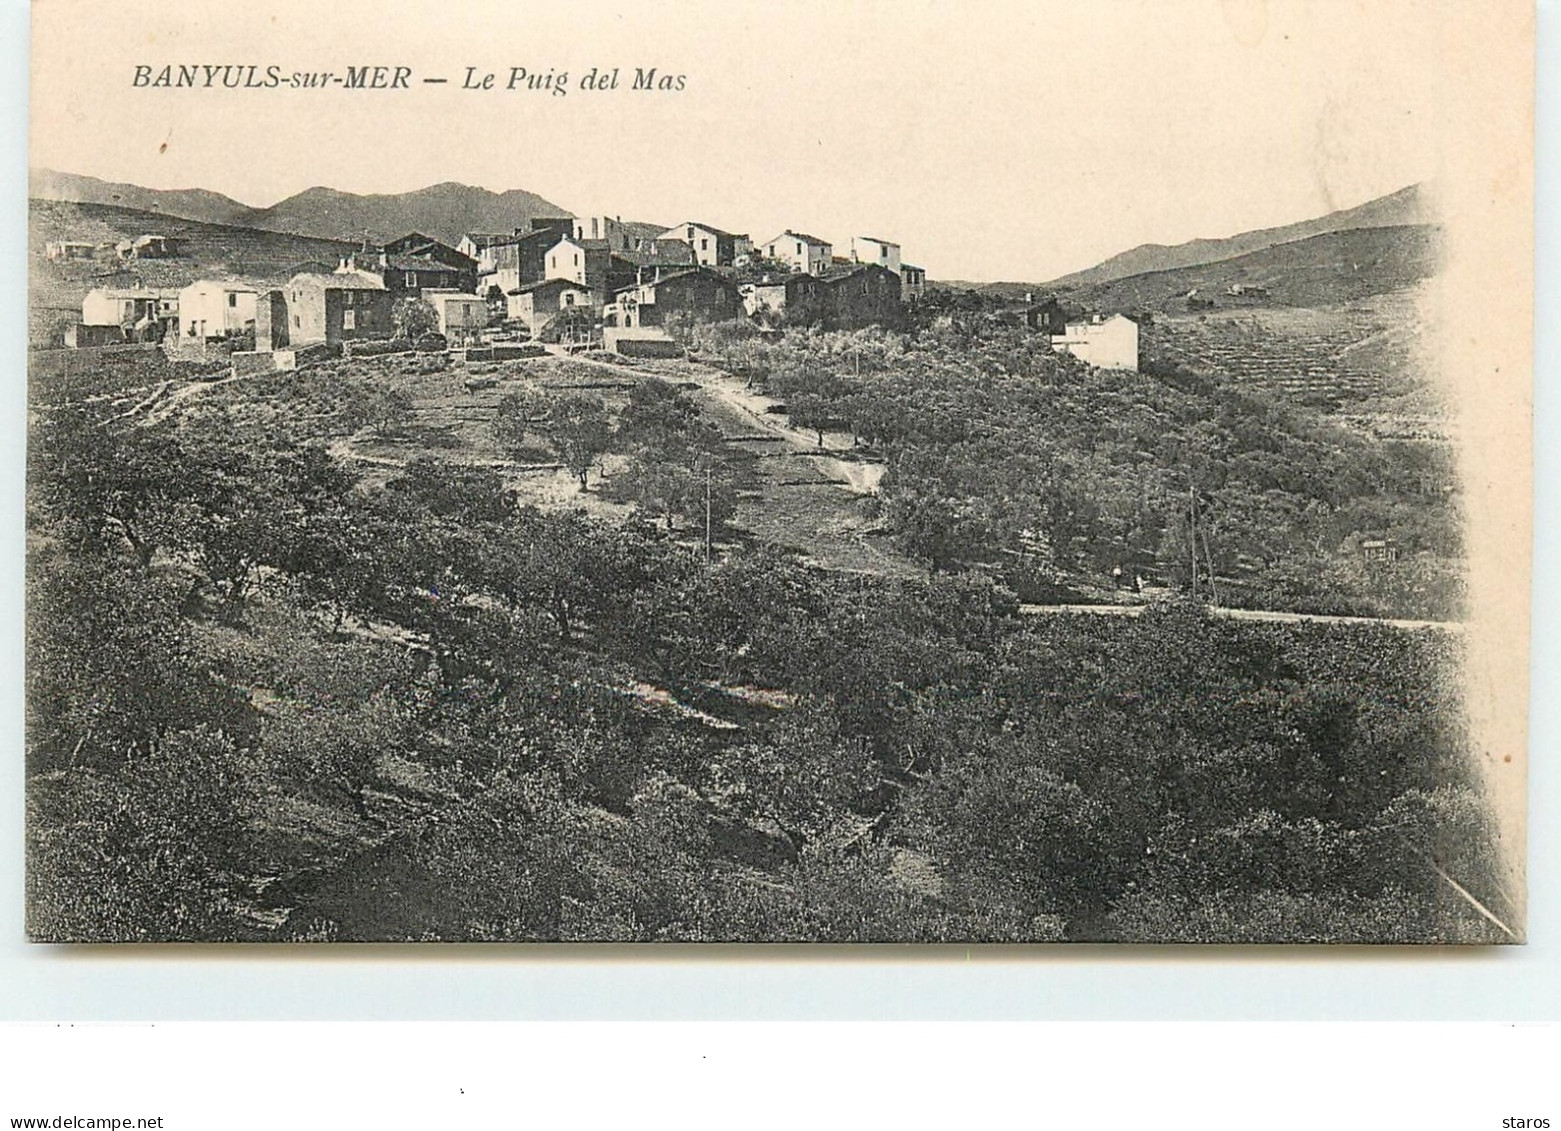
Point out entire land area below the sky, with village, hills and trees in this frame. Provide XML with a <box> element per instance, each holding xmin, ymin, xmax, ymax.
<box><xmin>27</xmin><ymin>172</ymin><xmax>1513</xmax><ymax>942</ymax></box>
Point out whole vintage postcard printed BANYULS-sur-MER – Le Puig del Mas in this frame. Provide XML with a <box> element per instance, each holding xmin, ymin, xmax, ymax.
<box><xmin>25</xmin><ymin>0</ymin><xmax>1533</xmax><ymax>944</ymax></box>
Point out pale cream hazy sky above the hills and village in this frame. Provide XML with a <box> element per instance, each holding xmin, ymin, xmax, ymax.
<box><xmin>31</xmin><ymin>0</ymin><xmax>1466</xmax><ymax>279</ymax></box>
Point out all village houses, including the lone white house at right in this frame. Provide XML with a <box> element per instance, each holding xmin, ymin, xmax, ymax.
<box><xmin>44</xmin><ymin>205</ymin><xmax>1138</xmax><ymax>371</ymax></box>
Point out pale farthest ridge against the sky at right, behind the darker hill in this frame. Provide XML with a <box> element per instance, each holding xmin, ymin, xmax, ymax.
<box><xmin>1042</xmin><ymin>184</ymin><xmax>1438</xmax><ymax>290</ymax></box>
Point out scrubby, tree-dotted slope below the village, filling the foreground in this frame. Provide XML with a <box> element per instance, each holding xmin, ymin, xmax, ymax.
<box><xmin>18</xmin><ymin>304</ymin><xmax>1505</xmax><ymax>942</ymax></box>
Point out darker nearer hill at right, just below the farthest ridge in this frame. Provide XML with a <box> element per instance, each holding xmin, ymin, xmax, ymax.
<box><xmin>1069</xmin><ymin>225</ymin><xmax>1441</xmax><ymax>312</ymax></box>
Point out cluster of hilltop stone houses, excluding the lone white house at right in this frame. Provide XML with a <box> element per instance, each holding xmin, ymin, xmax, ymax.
<box><xmin>67</xmin><ymin>215</ymin><xmax>926</xmax><ymax>349</ymax></box>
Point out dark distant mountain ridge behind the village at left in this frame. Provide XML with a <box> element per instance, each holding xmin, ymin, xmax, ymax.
<box><xmin>28</xmin><ymin>168</ymin><xmax>573</xmax><ymax>243</ymax></box>
